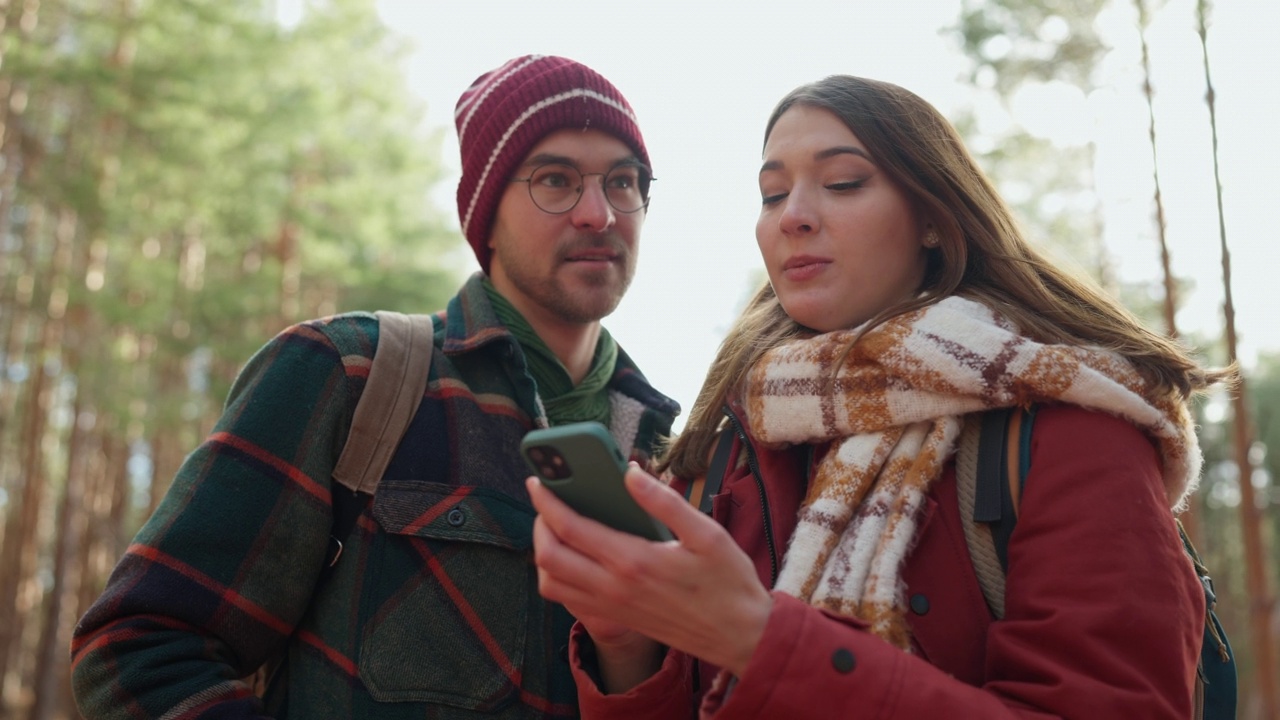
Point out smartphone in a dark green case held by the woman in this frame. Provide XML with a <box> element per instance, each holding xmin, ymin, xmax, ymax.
<box><xmin>520</xmin><ymin>423</ymin><xmax>672</xmax><ymax>542</ymax></box>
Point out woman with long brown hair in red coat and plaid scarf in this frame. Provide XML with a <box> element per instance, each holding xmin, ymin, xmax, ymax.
<box><xmin>529</xmin><ymin>76</ymin><xmax>1229</xmax><ymax>719</ymax></box>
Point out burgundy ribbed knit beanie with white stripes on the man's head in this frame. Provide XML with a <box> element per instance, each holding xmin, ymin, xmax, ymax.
<box><xmin>453</xmin><ymin>55</ymin><xmax>652</xmax><ymax>273</ymax></box>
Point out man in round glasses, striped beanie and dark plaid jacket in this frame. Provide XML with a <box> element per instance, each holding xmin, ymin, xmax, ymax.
<box><xmin>72</xmin><ymin>56</ymin><xmax>678</xmax><ymax>719</ymax></box>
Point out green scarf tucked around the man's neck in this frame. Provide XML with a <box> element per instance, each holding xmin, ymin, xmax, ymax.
<box><xmin>484</xmin><ymin>278</ymin><xmax>618</xmax><ymax>427</ymax></box>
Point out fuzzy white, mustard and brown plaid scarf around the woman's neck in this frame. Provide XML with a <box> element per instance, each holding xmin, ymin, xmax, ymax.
<box><xmin>744</xmin><ymin>297</ymin><xmax>1201</xmax><ymax>650</ymax></box>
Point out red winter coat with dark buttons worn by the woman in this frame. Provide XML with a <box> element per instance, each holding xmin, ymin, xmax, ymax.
<box><xmin>571</xmin><ymin>406</ymin><xmax>1204</xmax><ymax>720</ymax></box>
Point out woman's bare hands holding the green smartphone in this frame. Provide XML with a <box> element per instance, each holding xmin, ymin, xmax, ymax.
<box><xmin>527</xmin><ymin>466</ymin><xmax>773</xmax><ymax>676</ymax></box>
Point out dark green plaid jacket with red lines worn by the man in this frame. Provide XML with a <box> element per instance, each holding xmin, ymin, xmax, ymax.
<box><xmin>72</xmin><ymin>275</ymin><xmax>678</xmax><ymax>720</ymax></box>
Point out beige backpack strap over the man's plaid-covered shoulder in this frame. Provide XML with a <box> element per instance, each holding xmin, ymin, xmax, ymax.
<box><xmin>333</xmin><ymin>310</ymin><xmax>435</xmax><ymax>495</ymax></box>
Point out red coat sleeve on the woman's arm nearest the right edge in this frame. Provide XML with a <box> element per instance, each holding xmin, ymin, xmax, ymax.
<box><xmin>701</xmin><ymin>407</ymin><xmax>1204</xmax><ymax>720</ymax></box>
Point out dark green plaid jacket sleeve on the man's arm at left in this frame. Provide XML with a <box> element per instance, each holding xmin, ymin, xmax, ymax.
<box><xmin>72</xmin><ymin>324</ymin><xmax>352</xmax><ymax>720</ymax></box>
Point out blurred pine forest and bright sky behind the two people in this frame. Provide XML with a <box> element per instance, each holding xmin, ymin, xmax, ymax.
<box><xmin>0</xmin><ymin>0</ymin><xmax>1280</xmax><ymax>720</ymax></box>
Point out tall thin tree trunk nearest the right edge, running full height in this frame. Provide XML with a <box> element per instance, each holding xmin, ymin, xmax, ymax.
<box><xmin>1196</xmin><ymin>0</ymin><xmax>1280</xmax><ymax>717</ymax></box>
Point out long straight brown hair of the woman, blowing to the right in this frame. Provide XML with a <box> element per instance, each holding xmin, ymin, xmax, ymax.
<box><xmin>662</xmin><ymin>76</ymin><xmax>1234</xmax><ymax>478</ymax></box>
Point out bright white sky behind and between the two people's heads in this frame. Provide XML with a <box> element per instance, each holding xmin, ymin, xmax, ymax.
<box><xmin>337</xmin><ymin>0</ymin><xmax>1280</xmax><ymax>425</ymax></box>
